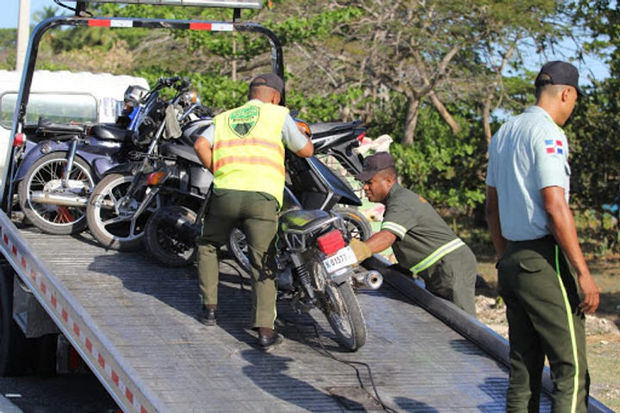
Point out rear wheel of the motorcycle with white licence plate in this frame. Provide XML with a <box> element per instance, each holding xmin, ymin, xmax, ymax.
<box><xmin>311</xmin><ymin>261</ymin><xmax>366</xmax><ymax>351</ymax></box>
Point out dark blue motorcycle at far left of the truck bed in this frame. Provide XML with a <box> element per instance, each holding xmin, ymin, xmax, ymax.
<box><xmin>14</xmin><ymin>86</ymin><xmax>147</xmax><ymax>235</ymax></box>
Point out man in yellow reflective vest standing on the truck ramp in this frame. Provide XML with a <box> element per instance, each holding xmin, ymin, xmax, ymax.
<box><xmin>194</xmin><ymin>73</ymin><xmax>314</xmax><ymax>349</ymax></box>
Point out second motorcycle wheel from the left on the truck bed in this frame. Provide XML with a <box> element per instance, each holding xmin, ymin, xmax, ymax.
<box><xmin>86</xmin><ymin>174</ymin><xmax>159</xmax><ymax>251</ymax></box>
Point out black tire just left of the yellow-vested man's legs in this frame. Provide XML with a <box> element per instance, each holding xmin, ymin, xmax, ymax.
<box><xmin>144</xmin><ymin>205</ymin><xmax>198</xmax><ymax>267</ymax></box>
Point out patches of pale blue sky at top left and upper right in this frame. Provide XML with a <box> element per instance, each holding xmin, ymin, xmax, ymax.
<box><xmin>0</xmin><ymin>0</ymin><xmax>615</xmax><ymax>84</ymax></box>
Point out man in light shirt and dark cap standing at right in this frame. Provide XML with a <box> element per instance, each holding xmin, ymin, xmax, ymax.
<box><xmin>486</xmin><ymin>61</ymin><xmax>599</xmax><ymax>412</ymax></box>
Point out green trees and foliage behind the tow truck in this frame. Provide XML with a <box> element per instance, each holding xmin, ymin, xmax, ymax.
<box><xmin>14</xmin><ymin>0</ymin><xmax>620</xmax><ymax>248</ymax></box>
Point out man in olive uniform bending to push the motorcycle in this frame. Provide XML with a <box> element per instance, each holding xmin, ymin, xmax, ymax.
<box><xmin>351</xmin><ymin>152</ymin><xmax>478</xmax><ymax>317</ymax></box>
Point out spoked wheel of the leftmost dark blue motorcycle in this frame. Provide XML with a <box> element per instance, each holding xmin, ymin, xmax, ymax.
<box><xmin>17</xmin><ymin>152</ymin><xmax>95</xmax><ymax>235</ymax></box>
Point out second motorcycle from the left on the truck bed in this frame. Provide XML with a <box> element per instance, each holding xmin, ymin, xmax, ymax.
<box><xmin>86</xmin><ymin>77</ymin><xmax>210</xmax><ymax>250</ymax></box>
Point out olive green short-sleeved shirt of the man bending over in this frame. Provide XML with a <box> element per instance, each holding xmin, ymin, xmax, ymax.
<box><xmin>381</xmin><ymin>183</ymin><xmax>458</xmax><ymax>268</ymax></box>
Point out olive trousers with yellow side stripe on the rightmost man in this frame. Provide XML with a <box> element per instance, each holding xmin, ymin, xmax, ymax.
<box><xmin>497</xmin><ymin>236</ymin><xmax>590</xmax><ymax>412</ymax></box>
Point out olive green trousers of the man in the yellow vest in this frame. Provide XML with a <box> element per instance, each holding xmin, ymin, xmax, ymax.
<box><xmin>198</xmin><ymin>189</ymin><xmax>279</xmax><ymax>328</ymax></box>
